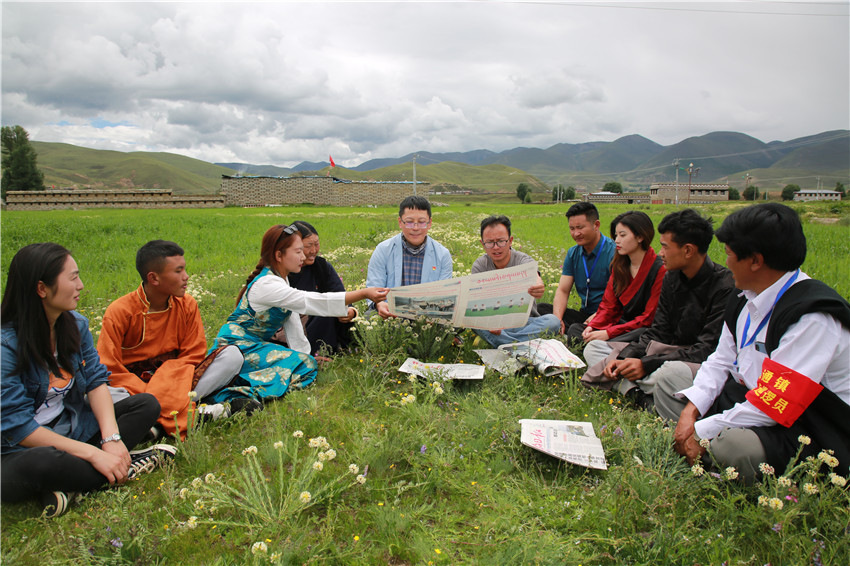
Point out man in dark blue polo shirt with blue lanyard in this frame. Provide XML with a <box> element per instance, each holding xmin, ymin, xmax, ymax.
<box><xmin>552</xmin><ymin>202</ymin><xmax>617</xmax><ymax>338</ymax></box>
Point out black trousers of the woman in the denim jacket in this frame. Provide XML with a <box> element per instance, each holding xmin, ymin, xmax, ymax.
<box><xmin>0</xmin><ymin>393</ymin><xmax>160</xmax><ymax>502</ymax></box>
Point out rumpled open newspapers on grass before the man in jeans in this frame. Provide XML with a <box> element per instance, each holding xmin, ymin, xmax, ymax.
<box><xmin>475</xmin><ymin>338</ymin><xmax>585</xmax><ymax>376</ymax></box>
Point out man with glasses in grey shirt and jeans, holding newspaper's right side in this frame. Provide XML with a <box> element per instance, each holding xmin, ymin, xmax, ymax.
<box><xmin>472</xmin><ymin>216</ymin><xmax>561</xmax><ymax>346</ymax></box>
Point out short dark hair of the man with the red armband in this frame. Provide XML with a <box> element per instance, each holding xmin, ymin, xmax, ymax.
<box><xmin>716</xmin><ymin>202</ymin><xmax>806</xmax><ymax>271</ymax></box>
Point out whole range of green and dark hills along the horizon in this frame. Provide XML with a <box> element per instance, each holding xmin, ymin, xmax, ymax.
<box><xmin>33</xmin><ymin>130</ymin><xmax>850</xmax><ymax>194</ymax></box>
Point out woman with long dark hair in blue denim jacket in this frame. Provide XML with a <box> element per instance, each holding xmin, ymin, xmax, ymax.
<box><xmin>0</xmin><ymin>243</ymin><xmax>174</xmax><ymax>516</ymax></box>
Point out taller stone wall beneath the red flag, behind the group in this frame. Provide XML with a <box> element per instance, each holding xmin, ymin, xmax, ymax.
<box><xmin>221</xmin><ymin>175</ymin><xmax>422</xmax><ymax>206</ymax></box>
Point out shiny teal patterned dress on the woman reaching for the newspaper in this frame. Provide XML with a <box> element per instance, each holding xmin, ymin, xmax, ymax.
<box><xmin>210</xmin><ymin>267</ymin><xmax>318</xmax><ymax>403</ymax></box>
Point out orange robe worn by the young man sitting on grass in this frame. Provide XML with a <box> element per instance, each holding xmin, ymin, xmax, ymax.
<box><xmin>97</xmin><ymin>285</ymin><xmax>207</xmax><ymax>439</ymax></box>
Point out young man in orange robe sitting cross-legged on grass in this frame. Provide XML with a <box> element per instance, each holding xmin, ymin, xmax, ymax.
<box><xmin>97</xmin><ymin>240</ymin><xmax>243</xmax><ymax>439</ymax></box>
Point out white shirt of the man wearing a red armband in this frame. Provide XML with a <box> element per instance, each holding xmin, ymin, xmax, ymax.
<box><xmin>676</xmin><ymin>272</ymin><xmax>850</xmax><ymax>440</ymax></box>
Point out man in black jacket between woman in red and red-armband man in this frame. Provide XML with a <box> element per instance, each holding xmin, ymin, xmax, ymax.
<box><xmin>582</xmin><ymin>208</ymin><xmax>734</xmax><ymax>410</ymax></box>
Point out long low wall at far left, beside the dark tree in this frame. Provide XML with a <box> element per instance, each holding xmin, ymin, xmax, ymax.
<box><xmin>6</xmin><ymin>189</ymin><xmax>224</xmax><ymax>210</ymax></box>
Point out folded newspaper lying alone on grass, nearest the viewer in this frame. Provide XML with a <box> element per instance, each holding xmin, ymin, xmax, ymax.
<box><xmin>519</xmin><ymin>419</ymin><xmax>608</xmax><ymax>470</ymax></box>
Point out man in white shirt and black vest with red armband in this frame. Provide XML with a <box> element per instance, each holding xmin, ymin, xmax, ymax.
<box><xmin>655</xmin><ymin>203</ymin><xmax>850</xmax><ymax>482</ymax></box>
